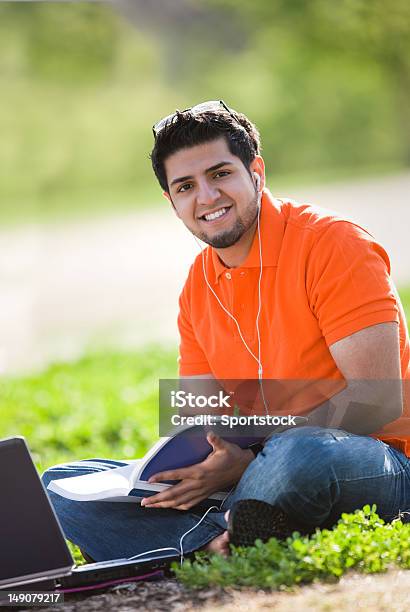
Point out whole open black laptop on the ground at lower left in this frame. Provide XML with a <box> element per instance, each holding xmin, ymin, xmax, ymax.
<box><xmin>0</xmin><ymin>437</ymin><xmax>179</xmax><ymax>591</ymax></box>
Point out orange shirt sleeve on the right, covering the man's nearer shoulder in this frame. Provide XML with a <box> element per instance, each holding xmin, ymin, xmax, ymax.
<box><xmin>306</xmin><ymin>221</ymin><xmax>399</xmax><ymax>346</ymax></box>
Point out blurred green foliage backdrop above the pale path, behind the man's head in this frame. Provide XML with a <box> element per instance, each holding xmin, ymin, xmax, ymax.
<box><xmin>0</xmin><ymin>0</ymin><xmax>410</xmax><ymax>225</ymax></box>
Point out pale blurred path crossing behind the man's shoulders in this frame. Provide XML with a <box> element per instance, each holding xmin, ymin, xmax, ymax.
<box><xmin>0</xmin><ymin>173</ymin><xmax>410</xmax><ymax>373</ymax></box>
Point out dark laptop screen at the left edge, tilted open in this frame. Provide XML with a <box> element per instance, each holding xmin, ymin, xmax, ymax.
<box><xmin>0</xmin><ymin>438</ymin><xmax>73</xmax><ymax>586</ymax></box>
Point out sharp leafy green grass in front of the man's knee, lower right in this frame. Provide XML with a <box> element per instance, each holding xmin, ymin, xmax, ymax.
<box><xmin>173</xmin><ymin>506</ymin><xmax>410</xmax><ymax>589</ymax></box>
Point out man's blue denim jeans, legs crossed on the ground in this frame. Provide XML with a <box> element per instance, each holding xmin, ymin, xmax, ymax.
<box><xmin>43</xmin><ymin>427</ymin><xmax>410</xmax><ymax>561</ymax></box>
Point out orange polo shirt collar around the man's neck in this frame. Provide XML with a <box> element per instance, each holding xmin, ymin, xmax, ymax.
<box><xmin>211</xmin><ymin>189</ymin><xmax>285</xmax><ymax>282</ymax></box>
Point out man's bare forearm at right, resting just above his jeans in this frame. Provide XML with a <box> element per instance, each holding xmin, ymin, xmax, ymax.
<box><xmin>307</xmin><ymin>380</ymin><xmax>402</xmax><ymax>435</ymax></box>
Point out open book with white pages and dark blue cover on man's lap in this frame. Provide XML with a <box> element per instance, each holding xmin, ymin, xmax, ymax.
<box><xmin>47</xmin><ymin>425</ymin><xmax>263</xmax><ymax>505</ymax></box>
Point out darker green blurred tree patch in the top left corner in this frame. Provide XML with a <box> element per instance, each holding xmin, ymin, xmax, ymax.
<box><xmin>0</xmin><ymin>2</ymin><xmax>120</xmax><ymax>85</ymax></box>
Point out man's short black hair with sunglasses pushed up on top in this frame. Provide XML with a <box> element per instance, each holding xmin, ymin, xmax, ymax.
<box><xmin>150</xmin><ymin>106</ymin><xmax>261</xmax><ymax>191</ymax></box>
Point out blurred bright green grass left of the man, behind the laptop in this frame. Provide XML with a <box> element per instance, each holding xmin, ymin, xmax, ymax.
<box><xmin>0</xmin><ymin>347</ymin><xmax>176</xmax><ymax>470</ymax></box>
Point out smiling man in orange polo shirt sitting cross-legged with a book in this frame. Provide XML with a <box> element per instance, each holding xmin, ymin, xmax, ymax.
<box><xmin>44</xmin><ymin>102</ymin><xmax>410</xmax><ymax>560</ymax></box>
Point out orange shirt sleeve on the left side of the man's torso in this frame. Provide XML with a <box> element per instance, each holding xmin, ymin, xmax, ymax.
<box><xmin>178</xmin><ymin>277</ymin><xmax>211</xmax><ymax>376</ymax></box>
